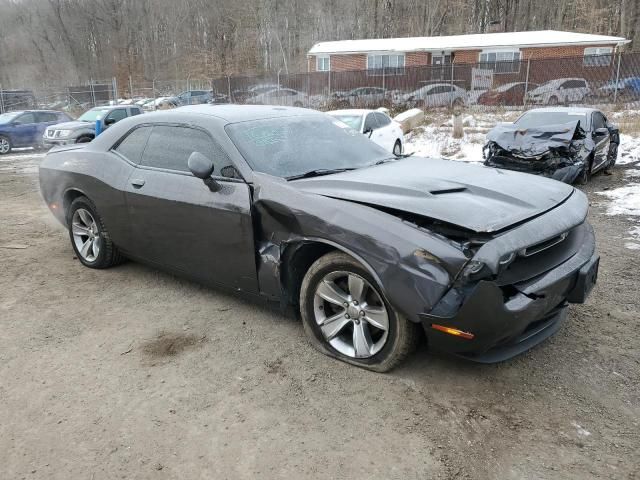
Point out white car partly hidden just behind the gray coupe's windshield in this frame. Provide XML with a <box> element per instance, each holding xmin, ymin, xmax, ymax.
<box><xmin>327</xmin><ymin>109</ymin><xmax>404</xmax><ymax>155</ymax></box>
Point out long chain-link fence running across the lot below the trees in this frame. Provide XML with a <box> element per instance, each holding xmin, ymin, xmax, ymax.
<box><xmin>0</xmin><ymin>52</ymin><xmax>640</xmax><ymax>115</ymax></box>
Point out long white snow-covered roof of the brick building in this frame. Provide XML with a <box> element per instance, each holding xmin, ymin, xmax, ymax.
<box><xmin>308</xmin><ymin>30</ymin><xmax>630</xmax><ymax>55</ymax></box>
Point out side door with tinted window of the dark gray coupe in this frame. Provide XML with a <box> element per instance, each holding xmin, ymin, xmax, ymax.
<box><xmin>126</xmin><ymin>125</ymin><xmax>258</xmax><ymax>292</ymax></box>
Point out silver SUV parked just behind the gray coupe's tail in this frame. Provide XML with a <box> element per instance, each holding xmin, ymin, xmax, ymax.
<box><xmin>42</xmin><ymin>105</ymin><xmax>142</xmax><ymax>147</ymax></box>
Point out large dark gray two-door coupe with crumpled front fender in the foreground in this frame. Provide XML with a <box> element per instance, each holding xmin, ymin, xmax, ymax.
<box><xmin>40</xmin><ymin>105</ymin><xmax>598</xmax><ymax>371</ymax></box>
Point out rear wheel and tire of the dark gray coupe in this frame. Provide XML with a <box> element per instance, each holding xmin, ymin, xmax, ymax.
<box><xmin>67</xmin><ymin>197</ymin><xmax>123</xmax><ymax>269</ymax></box>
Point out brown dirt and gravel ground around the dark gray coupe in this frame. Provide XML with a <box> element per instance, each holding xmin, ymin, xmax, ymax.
<box><xmin>0</xmin><ymin>152</ymin><xmax>640</xmax><ymax>480</ymax></box>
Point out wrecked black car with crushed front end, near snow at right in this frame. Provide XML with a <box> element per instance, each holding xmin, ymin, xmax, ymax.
<box><xmin>483</xmin><ymin>107</ymin><xmax>620</xmax><ymax>184</ymax></box>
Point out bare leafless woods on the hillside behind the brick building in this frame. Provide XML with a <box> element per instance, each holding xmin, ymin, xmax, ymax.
<box><xmin>0</xmin><ymin>0</ymin><xmax>640</xmax><ymax>88</ymax></box>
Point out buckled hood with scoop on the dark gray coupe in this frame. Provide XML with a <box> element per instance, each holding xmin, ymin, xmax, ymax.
<box><xmin>291</xmin><ymin>157</ymin><xmax>573</xmax><ymax>233</ymax></box>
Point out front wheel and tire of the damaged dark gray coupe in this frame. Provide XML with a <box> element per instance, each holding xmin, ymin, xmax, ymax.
<box><xmin>300</xmin><ymin>252</ymin><xmax>419</xmax><ymax>372</ymax></box>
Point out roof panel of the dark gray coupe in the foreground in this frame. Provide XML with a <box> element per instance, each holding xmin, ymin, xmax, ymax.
<box><xmin>174</xmin><ymin>104</ymin><xmax>323</xmax><ymax>123</ymax></box>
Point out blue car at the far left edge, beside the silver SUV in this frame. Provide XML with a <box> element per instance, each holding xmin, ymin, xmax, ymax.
<box><xmin>0</xmin><ymin>110</ymin><xmax>71</xmax><ymax>155</ymax></box>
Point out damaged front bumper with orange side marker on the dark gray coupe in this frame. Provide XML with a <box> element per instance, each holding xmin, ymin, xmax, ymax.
<box><xmin>420</xmin><ymin>223</ymin><xmax>599</xmax><ymax>363</ymax></box>
